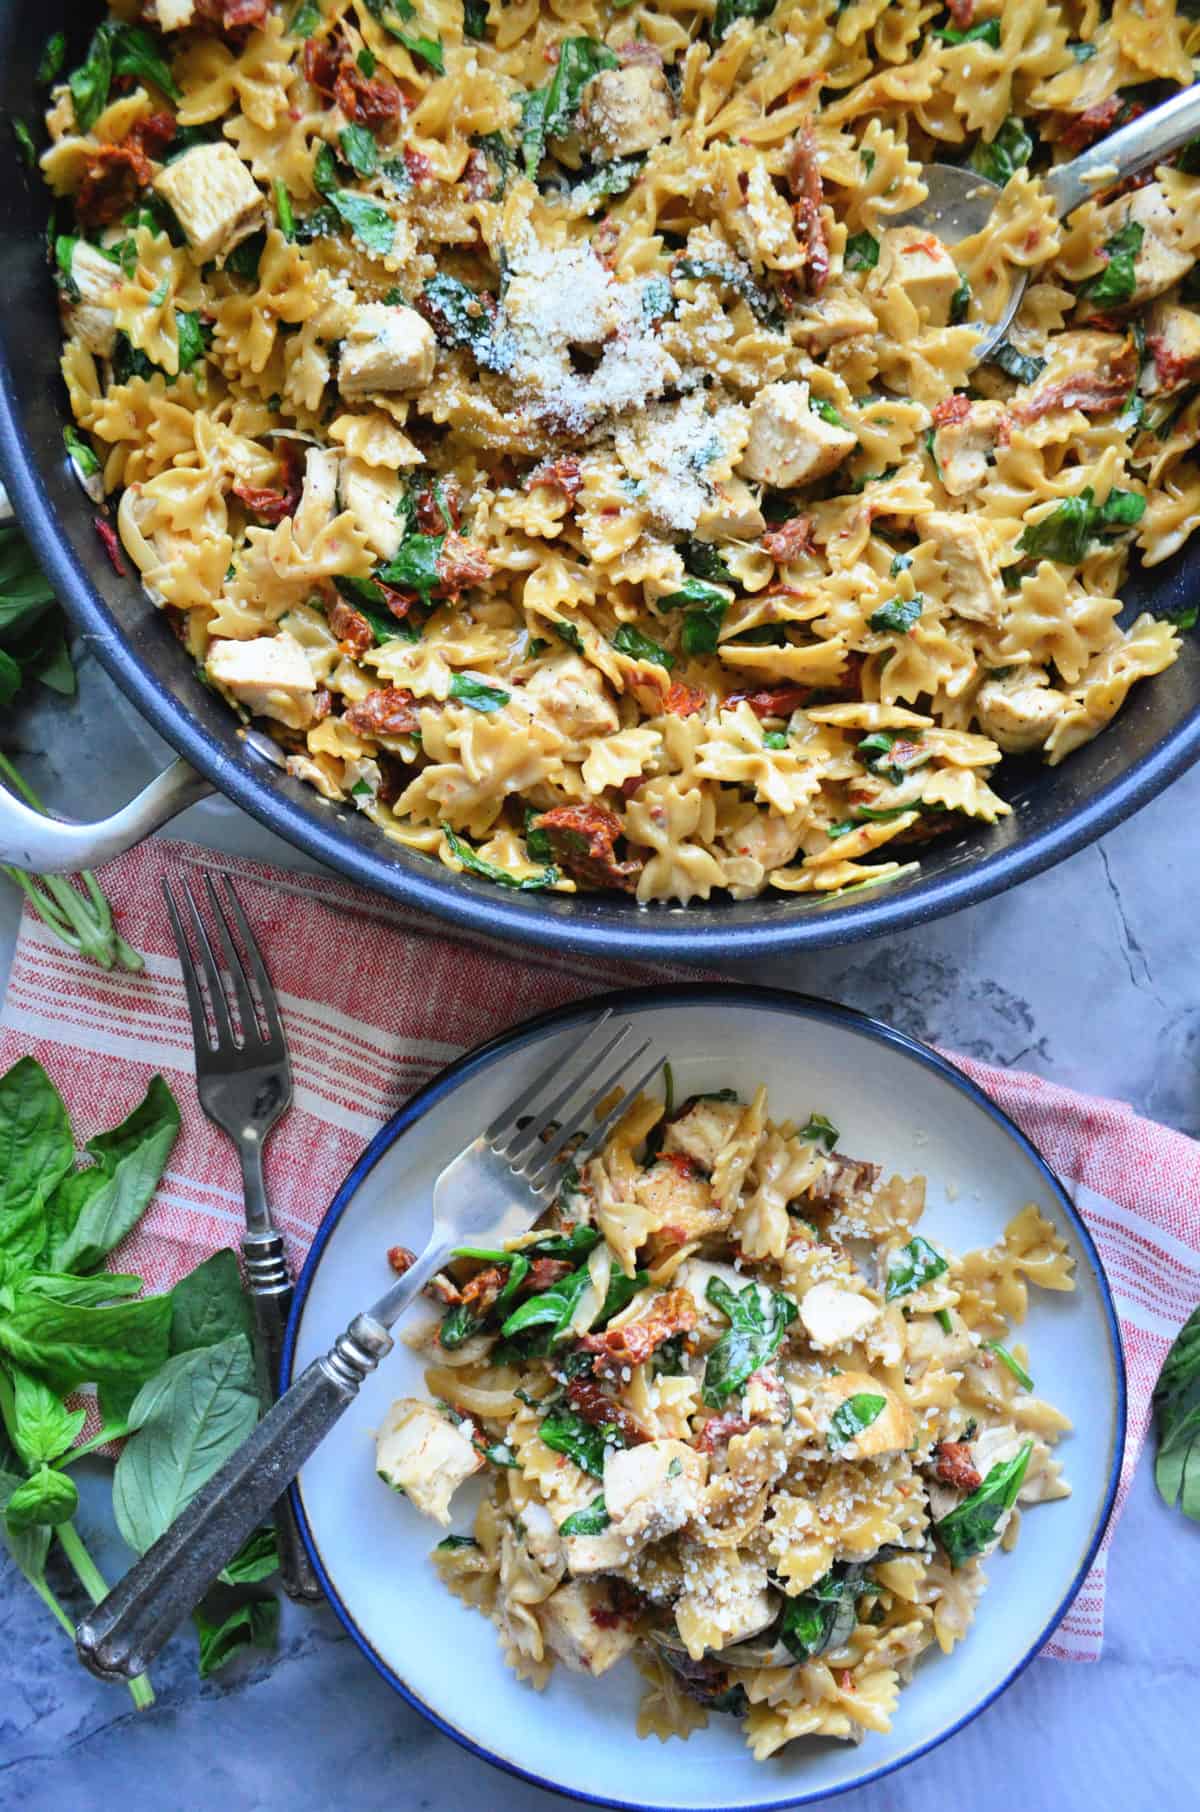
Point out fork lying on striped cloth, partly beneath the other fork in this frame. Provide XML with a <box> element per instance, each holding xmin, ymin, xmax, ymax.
<box><xmin>163</xmin><ymin>875</ymin><xmax>324</xmax><ymax>1604</ymax></box>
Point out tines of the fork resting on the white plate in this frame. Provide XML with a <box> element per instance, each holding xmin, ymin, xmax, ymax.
<box><xmin>484</xmin><ymin>1007</ymin><xmax>663</xmax><ymax>1194</ymax></box>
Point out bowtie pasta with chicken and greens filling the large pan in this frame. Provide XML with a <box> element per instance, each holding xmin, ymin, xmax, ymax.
<box><xmin>42</xmin><ymin>0</ymin><xmax>1200</xmax><ymax>902</ymax></box>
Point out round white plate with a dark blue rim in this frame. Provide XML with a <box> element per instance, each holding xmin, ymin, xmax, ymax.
<box><xmin>285</xmin><ymin>986</ymin><xmax>1126</xmax><ymax>1812</ymax></box>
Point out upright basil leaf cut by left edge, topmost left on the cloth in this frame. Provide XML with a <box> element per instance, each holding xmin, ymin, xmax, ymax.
<box><xmin>0</xmin><ymin>1056</ymin><xmax>74</xmax><ymax>1265</ymax></box>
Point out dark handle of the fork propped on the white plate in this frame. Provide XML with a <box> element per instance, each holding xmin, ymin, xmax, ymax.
<box><xmin>74</xmin><ymin>1316</ymin><xmax>392</xmax><ymax>1680</ymax></box>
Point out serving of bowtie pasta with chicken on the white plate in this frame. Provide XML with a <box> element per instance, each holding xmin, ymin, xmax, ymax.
<box><xmin>375</xmin><ymin>1089</ymin><xmax>1073</xmax><ymax>1759</ymax></box>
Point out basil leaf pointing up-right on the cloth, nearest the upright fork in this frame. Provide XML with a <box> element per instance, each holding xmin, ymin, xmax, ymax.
<box><xmin>47</xmin><ymin>1076</ymin><xmax>179</xmax><ymax>1272</ymax></box>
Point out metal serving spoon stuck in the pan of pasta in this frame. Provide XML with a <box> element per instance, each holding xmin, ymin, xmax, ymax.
<box><xmin>892</xmin><ymin>82</ymin><xmax>1200</xmax><ymax>359</ymax></box>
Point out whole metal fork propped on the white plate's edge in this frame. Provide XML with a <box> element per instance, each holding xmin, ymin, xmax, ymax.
<box><xmin>74</xmin><ymin>1011</ymin><xmax>663</xmax><ymax>1680</ymax></box>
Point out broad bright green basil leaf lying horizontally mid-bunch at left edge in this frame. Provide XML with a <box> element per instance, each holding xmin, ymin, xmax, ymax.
<box><xmin>0</xmin><ymin>1287</ymin><xmax>170</xmax><ymax>1393</ymax></box>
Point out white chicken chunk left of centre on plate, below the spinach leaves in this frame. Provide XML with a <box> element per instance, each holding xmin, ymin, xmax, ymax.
<box><xmin>566</xmin><ymin>1441</ymin><xmax>709</xmax><ymax>1575</ymax></box>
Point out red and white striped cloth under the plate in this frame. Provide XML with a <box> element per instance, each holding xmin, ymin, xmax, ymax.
<box><xmin>0</xmin><ymin>843</ymin><xmax>1200</xmax><ymax>1662</ymax></box>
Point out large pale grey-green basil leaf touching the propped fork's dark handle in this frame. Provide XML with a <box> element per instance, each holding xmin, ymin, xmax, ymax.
<box><xmin>112</xmin><ymin>1333</ymin><xmax>259</xmax><ymax>1553</ymax></box>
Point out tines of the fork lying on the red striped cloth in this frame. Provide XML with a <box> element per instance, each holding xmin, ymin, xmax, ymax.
<box><xmin>163</xmin><ymin>875</ymin><xmax>286</xmax><ymax>1064</ymax></box>
